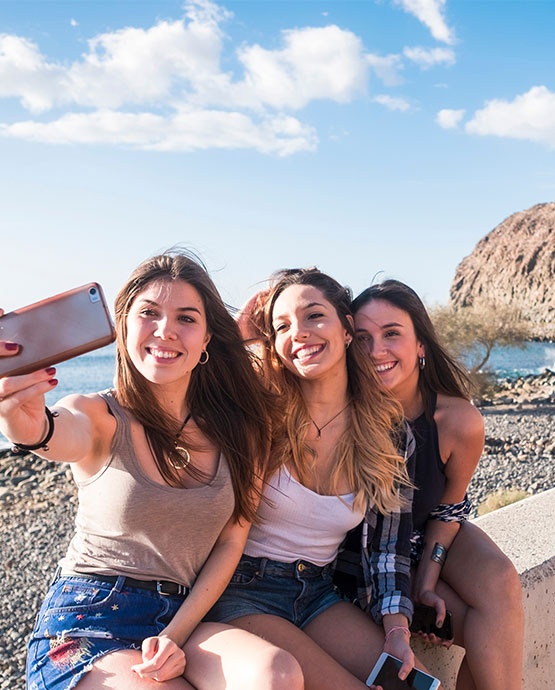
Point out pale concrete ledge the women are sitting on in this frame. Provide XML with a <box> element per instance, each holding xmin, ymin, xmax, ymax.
<box><xmin>413</xmin><ymin>489</ymin><xmax>555</xmax><ymax>690</ymax></box>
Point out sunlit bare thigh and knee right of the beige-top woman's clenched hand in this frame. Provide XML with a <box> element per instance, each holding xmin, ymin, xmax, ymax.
<box><xmin>183</xmin><ymin>623</ymin><xmax>303</xmax><ymax>690</ymax></box>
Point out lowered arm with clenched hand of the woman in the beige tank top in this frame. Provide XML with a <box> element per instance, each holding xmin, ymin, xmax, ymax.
<box><xmin>132</xmin><ymin>510</ymin><xmax>250</xmax><ymax>680</ymax></box>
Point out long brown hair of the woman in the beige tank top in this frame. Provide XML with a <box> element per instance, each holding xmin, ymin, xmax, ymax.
<box><xmin>115</xmin><ymin>250</ymin><xmax>271</xmax><ymax>521</ymax></box>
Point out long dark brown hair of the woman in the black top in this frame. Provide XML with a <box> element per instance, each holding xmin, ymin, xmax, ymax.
<box><xmin>351</xmin><ymin>280</ymin><xmax>472</xmax><ymax>419</ymax></box>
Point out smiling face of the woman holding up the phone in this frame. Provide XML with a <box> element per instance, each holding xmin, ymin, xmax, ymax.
<box><xmin>127</xmin><ymin>280</ymin><xmax>210</xmax><ymax>387</ymax></box>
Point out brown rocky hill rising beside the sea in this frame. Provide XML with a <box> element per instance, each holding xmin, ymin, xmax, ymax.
<box><xmin>450</xmin><ymin>203</ymin><xmax>555</xmax><ymax>340</ymax></box>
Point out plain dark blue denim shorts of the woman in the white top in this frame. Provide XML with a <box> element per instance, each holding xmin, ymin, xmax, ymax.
<box><xmin>204</xmin><ymin>556</ymin><xmax>344</xmax><ymax>628</ymax></box>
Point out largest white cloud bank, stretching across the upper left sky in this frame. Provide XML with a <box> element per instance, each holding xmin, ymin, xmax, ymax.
<box><xmin>0</xmin><ymin>0</ymin><xmax>441</xmax><ymax>155</ymax></box>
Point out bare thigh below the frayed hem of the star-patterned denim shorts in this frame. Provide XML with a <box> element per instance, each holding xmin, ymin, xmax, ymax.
<box><xmin>75</xmin><ymin>649</ymin><xmax>194</xmax><ymax>690</ymax></box>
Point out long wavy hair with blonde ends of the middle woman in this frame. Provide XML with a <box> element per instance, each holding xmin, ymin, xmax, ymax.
<box><xmin>264</xmin><ymin>268</ymin><xmax>410</xmax><ymax>512</ymax></box>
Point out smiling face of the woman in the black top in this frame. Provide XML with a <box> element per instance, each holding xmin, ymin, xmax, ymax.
<box><xmin>355</xmin><ymin>299</ymin><xmax>425</xmax><ymax>395</ymax></box>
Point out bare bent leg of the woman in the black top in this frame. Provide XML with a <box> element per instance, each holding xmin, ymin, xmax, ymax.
<box><xmin>441</xmin><ymin>523</ymin><xmax>524</xmax><ymax>690</ymax></box>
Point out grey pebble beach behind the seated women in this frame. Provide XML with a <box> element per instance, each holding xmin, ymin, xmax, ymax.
<box><xmin>0</xmin><ymin>369</ymin><xmax>555</xmax><ymax>690</ymax></box>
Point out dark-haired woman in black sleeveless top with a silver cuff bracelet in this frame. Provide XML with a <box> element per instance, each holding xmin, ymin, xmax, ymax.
<box><xmin>352</xmin><ymin>280</ymin><xmax>523</xmax><ymax>690</ymax></box>
